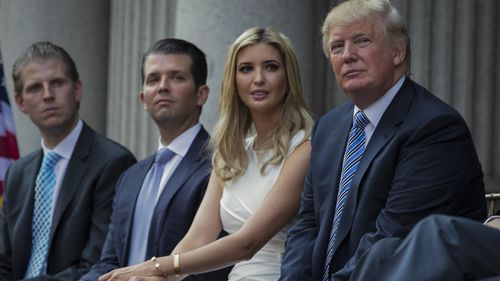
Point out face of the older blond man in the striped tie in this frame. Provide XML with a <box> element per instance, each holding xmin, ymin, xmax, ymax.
<box><xmin>328</xmin><ymin>17</ymin><xmax>405</xmax><ymax>109</ymax></box>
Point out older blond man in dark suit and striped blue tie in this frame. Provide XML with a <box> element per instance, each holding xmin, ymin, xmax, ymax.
<box><xmin>281</xmin><ymin>0</ymin><xmax>486</xmax><ymax>280</ymax></box>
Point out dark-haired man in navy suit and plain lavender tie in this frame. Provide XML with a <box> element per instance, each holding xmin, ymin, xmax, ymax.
<box><xmin>82</xmin><ymin>39</ymin><xmax>228</xmax><ymax>281</ymax></box>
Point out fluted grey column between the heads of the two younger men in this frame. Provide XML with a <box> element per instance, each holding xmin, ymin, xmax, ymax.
<box><xmin>107</xmin><ymin>0</ymin><xmax>175</xmax><ymax>159</ymax></box>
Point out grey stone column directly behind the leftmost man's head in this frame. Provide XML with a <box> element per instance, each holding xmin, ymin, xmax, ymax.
<box><xmin>0</xmin><ymin>0</ymin><xmax>109</xmax><ymax>155</ymax></box>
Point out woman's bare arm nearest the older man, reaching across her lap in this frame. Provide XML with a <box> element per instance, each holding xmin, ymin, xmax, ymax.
<box><xmin>100</xmin><ymin>141</ymin><xmax>311</xmax><ymax>280</ymax></box>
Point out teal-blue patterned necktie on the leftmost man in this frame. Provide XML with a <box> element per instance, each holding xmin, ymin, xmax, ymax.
<box><xmin>24</xmin><ymin>152</ymin><xmax>61</xmax><ymax>278</ymax></box>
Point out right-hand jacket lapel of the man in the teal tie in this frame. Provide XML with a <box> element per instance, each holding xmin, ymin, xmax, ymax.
<box><xmin>50</xmin><ymin>123</ymin><xmax>94</xmax><ymax>237</ymax></box>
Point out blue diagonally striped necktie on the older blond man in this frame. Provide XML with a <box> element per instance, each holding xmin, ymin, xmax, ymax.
<box><xmin>322</xmin><ymin>111</ymin><xmax>370</xmax><ymax>281</ymax></box>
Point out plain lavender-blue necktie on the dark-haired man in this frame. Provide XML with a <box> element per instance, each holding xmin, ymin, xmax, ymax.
<box><xmin>128</xmin><ymin>148</ymin><xmax>175</xmax><ymax>265</ymax></box>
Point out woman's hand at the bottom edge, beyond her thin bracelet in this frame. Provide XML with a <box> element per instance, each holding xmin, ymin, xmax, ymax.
<box><xmin>99</xmin><ymin>261</ymin><xmax>157</xmax><ymax>281</ymax></box>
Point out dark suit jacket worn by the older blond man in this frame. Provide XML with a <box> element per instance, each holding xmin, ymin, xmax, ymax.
<box><xmin>281</xmin><ymin>78</ymin><xmax>486</xmax><ymax>280</ymax></box>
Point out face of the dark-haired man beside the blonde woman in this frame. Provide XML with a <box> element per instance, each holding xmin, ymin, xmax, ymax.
<box><xmin>140</xmin><ymin>54</ymin><xmax>208</xmax><ymax>129</ymax></box>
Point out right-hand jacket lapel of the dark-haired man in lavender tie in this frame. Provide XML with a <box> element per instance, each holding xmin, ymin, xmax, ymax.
<box><xmin>147</xmin><ymin>128</ymin><xmax>208</xmax><ymax>255</ymax></box>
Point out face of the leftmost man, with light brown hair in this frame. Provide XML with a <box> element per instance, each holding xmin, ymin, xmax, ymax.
<box><xmin>15</xmin><ymin>59</ymin><xmax>82</xmax><ymax>135</ymax></box>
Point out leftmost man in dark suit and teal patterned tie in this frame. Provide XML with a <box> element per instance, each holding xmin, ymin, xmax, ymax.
<box><xmin>0</xmin><ymin>42</ymin><xmax>135</xmax><ymax>280</ymax></box>
